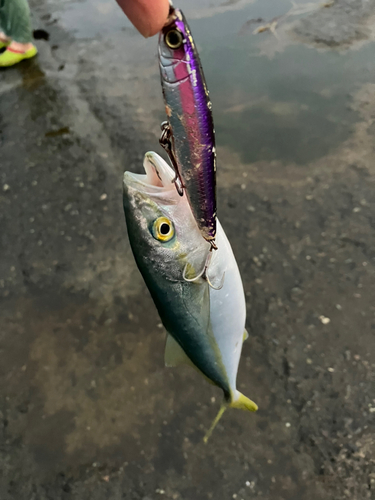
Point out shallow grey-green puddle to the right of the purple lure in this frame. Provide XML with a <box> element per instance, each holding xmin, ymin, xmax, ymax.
<box><xmin>190</xmin><ymin>0</ymin><xmax>375</xmax><ymax>164</ymax></box>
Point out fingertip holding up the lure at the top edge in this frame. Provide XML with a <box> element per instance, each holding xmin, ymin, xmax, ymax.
<box><xmin>116</xmin><ymin>0</ymin><xmax>169</xmax><ymax>38</ymax></box>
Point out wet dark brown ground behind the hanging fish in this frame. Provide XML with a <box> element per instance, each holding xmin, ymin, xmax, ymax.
<box><xmin>0</xmin><ymin>0</ymin><xmax>375</xmax><ymax>500</ymax></box>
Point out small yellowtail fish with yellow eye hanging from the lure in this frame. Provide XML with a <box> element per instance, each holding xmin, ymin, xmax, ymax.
<box><xmin>123</xmin><ymin>153</ymin><xmax>257</xmax><ymax>438</ymax></box>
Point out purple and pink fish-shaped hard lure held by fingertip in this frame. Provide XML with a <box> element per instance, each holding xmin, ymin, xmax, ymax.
<box><xmin>158</xmin><ymin>8</ymin><xmax>217</xmax><ymax>242</ymax></box>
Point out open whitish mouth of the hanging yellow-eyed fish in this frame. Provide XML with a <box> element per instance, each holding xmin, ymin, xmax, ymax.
<box><xmin>124</xmin><ymin>151</ymin><xmax>175</xmax><ymax>193</ymax></box>
